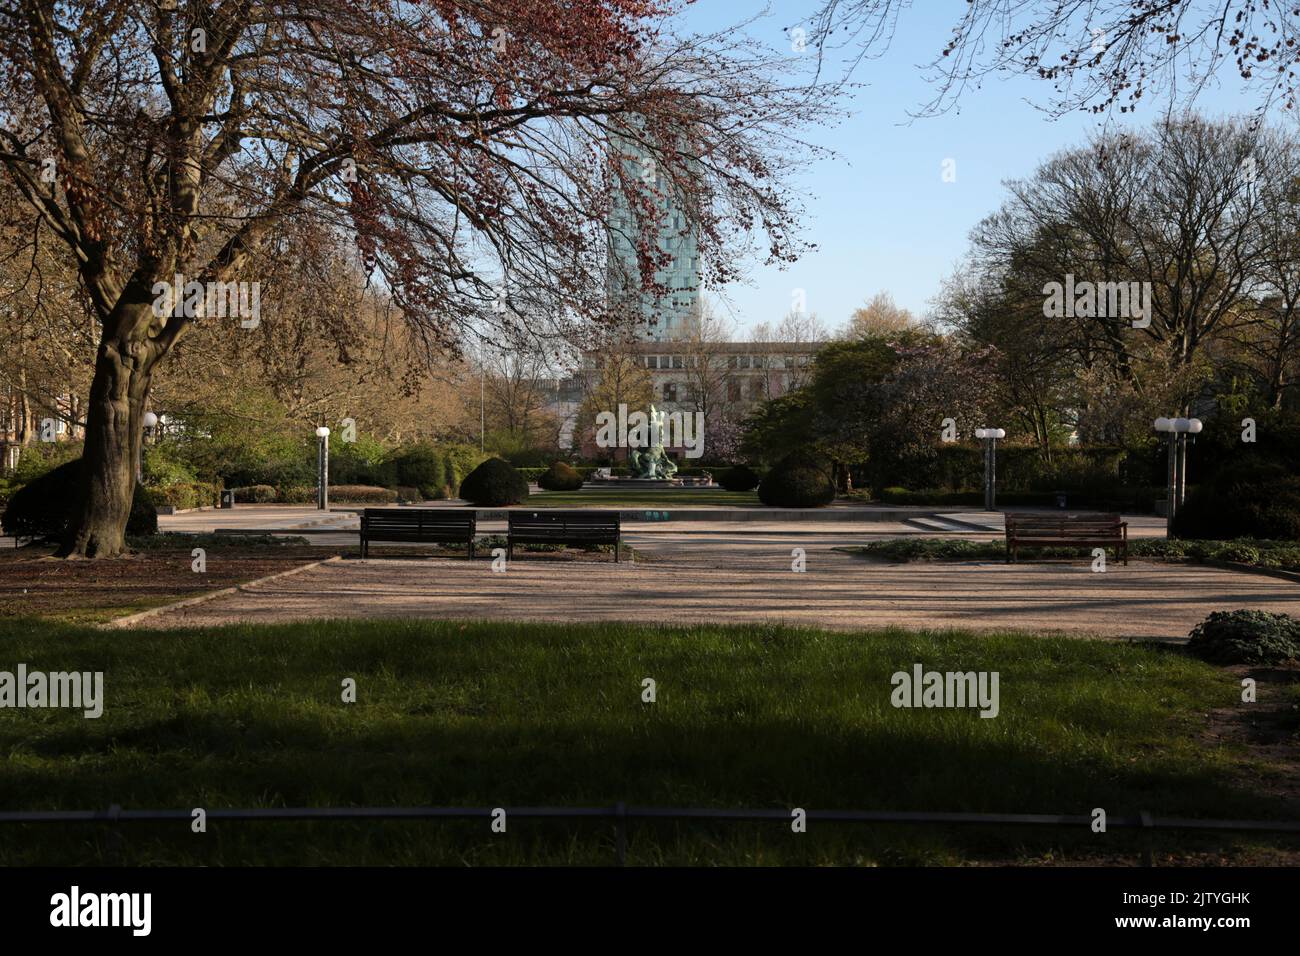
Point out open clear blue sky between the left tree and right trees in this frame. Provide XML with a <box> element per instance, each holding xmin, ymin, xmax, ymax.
<box><xmin>680</xmin><ymin>0</ymin><xmax>1256</xmax><ymax>329</ymax></box>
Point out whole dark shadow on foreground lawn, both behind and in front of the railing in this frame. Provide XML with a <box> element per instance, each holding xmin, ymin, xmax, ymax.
<box><xmin>0</xmin><ymin>714</ymin><xmax>1286</xmax><ymax>865</ymax></box>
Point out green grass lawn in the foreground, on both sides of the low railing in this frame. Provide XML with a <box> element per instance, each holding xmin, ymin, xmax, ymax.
<box><xmin>0</xmin><ymin>619</ymin><xmax>1284</xmax><ymax>865</ymax></box>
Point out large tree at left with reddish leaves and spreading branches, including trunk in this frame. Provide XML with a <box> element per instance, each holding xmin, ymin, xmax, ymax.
<box><xmin>0</xmin><ymin>0</ymin><xmax>824</xmax><ymax>557</ymax></box>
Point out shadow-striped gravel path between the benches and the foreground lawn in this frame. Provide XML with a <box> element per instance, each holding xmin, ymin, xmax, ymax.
<box><xmin>137</xmin><ymin>535</ymin><xmax>1300</xmax><ymax>640</ymax></box>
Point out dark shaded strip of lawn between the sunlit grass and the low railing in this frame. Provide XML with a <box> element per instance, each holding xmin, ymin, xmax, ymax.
<box><xmin>0</xmin><ymin>709</ymin><xmax>1288</xmax><ymax>818</ymax></box>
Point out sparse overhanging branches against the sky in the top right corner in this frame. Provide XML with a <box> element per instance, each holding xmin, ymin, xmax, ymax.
<box><xmin>807</xmin><ymin>0</ymin><xmax>1300</xmax><ymax>114</ymax></box>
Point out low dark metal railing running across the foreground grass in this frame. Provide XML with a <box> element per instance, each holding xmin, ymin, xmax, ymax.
<box><xmin>0</xmin><ymin>803</ymin><xmax>1300</xmax><ymax>866</ymax></box>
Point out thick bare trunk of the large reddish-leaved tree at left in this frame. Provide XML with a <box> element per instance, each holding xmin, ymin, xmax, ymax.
<box><xmin>59</xmin><ymin>325</ymin><xmax>153</xmax><ymax>558</ymax></box>
